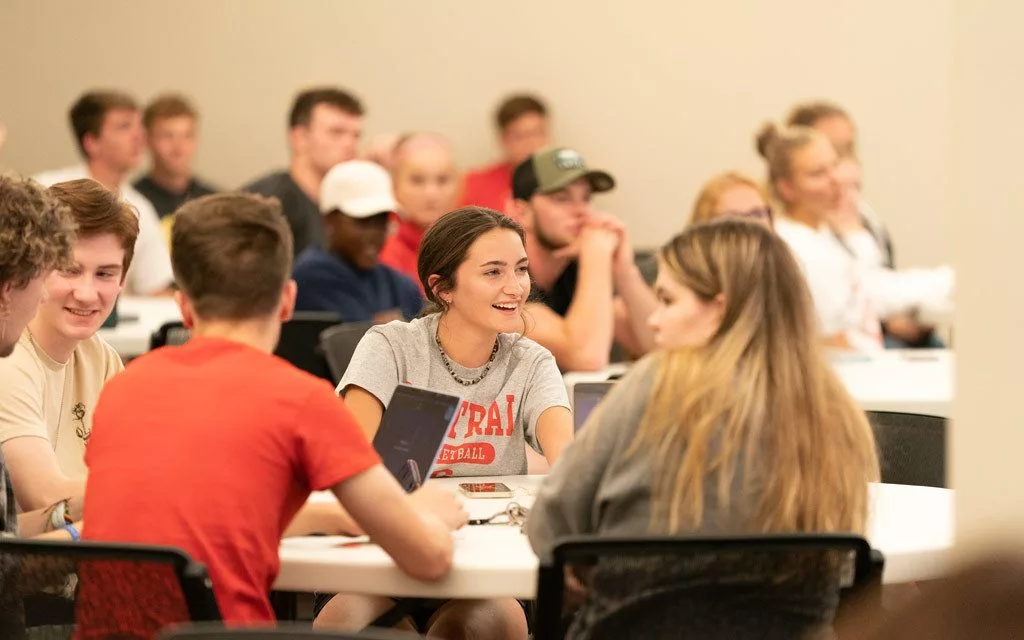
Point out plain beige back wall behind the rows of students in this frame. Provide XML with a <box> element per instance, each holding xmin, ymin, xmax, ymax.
<box><xmin>0</xmin><ymin>0</ymin><xmax>951</xmax><ymax>264</ymax></box>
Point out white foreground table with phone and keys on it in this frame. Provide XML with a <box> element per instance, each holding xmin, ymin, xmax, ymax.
<box><xmin>274</xmin><ymin>476</ymin><xmax>953</xmax><ymax>599</ymax></box>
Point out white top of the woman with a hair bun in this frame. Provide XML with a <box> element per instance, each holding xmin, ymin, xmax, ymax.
<box><xmin>775</xmin><ymin>218</ymin><xmax>883</xmax><ymax>351</ymax></box>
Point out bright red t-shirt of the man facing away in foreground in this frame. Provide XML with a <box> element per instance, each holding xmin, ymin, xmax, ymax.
<box><xmin>83</xmin><ymin>337</ymin><xmax>380</xmax><ymax>623</ymax></box>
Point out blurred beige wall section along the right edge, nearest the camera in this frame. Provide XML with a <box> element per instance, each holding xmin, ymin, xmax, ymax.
<box><xmin>949</xmin><ymin>0</ymin><xmax>1024</xmax><ymax>551</ymax></box>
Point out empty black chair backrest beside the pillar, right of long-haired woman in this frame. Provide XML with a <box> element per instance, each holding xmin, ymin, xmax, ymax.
<box><xmin>867</xmin><ymin>411</ymin><xmax>947</xmax><ymax>487</ymax></box>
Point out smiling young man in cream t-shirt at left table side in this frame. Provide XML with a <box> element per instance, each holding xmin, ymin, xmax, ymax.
<box><xmin>0</xmin><ymin>179</ymin><xmax>138</xmax><ymax>515</ymax></box>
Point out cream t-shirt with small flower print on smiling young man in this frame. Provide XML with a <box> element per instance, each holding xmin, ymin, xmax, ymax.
<box><xmin>0</xmin><ymin>330</ymin><xmax>124</xmax><ymax>478</ymax></box>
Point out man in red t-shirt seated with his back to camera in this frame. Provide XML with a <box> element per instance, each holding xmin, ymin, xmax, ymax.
<box><xmin>84</xmin><ymin>194</ymin><xmax>467</xmax><ymax>623</ymax></box>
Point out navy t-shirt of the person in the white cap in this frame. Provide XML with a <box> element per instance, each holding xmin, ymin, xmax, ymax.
<box><xmin>292</xmin><ymin>247</ymin><xmax>423</xmax><ymax>323</ymax></box>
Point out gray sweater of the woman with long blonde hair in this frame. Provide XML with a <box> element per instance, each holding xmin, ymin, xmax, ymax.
<box><xmin>526</xmin><ymin>355</ymin><xmax>838</xmax><ymax>640</ymax></box>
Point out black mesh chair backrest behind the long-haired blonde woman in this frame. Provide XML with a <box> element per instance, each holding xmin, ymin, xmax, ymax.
<box><xmin>535</xmin><ymin>535</ymin><xmax>884</xmax><ymax>640</ymax></box>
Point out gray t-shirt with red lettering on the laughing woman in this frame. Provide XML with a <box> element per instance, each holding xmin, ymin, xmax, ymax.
<box><xmin>338</xmin><ymin>313</ymin><xmax>569</xmax><ymax>476</ymax></box>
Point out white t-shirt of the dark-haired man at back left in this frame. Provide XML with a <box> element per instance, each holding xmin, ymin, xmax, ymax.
<box><xmin>35</xmin><ymin>165</ymin><xmax>174</xmax><ymax>296</ymax></box>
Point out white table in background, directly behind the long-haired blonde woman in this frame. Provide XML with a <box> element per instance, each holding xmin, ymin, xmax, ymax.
<box><xmin>562</xmin><ymin>349</ymin><xmax>953</xmax><ymax>418</ymax></box>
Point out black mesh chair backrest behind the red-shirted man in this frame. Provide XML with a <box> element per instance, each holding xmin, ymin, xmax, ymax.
<box><xmin>0</xmin><ymin>539</ymin><xmax>220</xmax><ymax>640</ymax></box>
